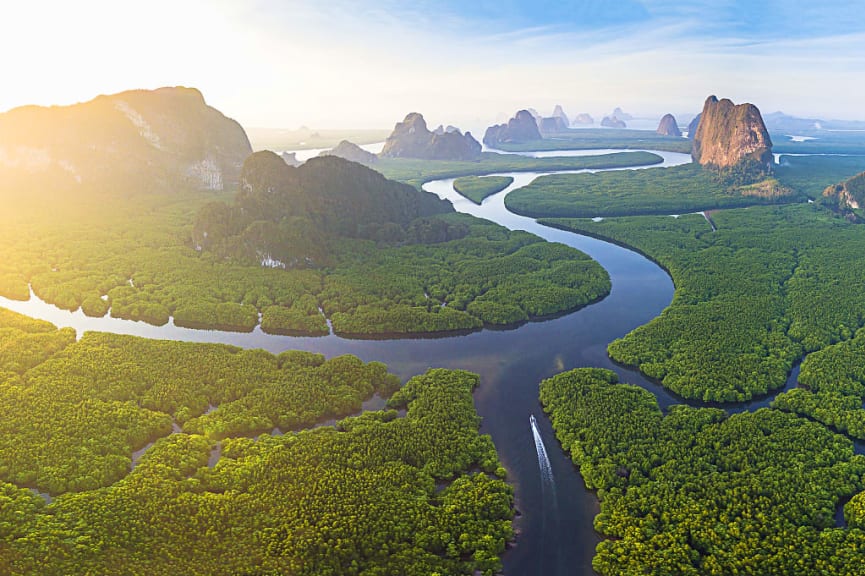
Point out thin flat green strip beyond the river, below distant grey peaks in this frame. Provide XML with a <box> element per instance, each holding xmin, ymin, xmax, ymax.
<box><xmin>375</xmin><ymin>152</ymin><xmax>664</xmax><ymax>187</ymax></box>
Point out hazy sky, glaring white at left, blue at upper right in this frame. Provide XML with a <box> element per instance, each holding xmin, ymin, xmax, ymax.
<box><xmin>0</xmin><ymin>0</ymin><xmax>865</xmax><ymax>129</ymax></box>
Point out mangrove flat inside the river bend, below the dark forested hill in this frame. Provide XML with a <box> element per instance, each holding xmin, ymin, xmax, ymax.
<box><xmin>22</xmin><ymin>214</ymin><xmax>610</xmax><ymax>334</ymax></box>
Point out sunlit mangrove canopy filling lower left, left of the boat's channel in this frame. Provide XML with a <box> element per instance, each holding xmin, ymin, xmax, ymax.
<box><xmin>0</xmin><ymin>310</ymin><xmax>513</xmax><ymax>576</ymax></box>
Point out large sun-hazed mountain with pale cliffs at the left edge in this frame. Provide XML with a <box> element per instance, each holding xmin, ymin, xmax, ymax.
<box><xmin>0</xmin><ymin>87</ymin><xmax>252</xmax><ymax>194</ymax></box>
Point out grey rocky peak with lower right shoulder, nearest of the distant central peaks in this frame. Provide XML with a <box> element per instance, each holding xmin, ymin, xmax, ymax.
<box><xmin>381</xmin><ymin>112</ymin><xmax>481</xmax><ymax>160</ymax></box>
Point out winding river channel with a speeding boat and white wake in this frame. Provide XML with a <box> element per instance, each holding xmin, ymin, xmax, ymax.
<box><xmin>0</xmin><ymin>151</ymin><xmax>836</xmax><ymax>576</ymax></box>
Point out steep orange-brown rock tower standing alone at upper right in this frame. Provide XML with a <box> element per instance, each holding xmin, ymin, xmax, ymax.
<box><xmin>691</xmin><ymin>96</ymin><xmax>772</xmax><ymax>168</ymax></box>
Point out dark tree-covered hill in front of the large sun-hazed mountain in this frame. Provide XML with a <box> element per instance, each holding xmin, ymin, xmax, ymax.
<box><xmin>193</xmin><ymin>151</ymin><xmax>456</xmax><ymax>267</ymax></box>
